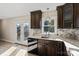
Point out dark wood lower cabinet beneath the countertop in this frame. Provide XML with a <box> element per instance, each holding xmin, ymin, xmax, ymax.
<box><xmin>37</xmin><ymin>39</ymin><xmax>67</xmax><ymax>56</ymax></box>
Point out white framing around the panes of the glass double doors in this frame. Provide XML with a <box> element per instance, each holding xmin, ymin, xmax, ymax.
<box><xmin>16</xmin><ymin>22</ymin><xmax>30</xmax><ymax>45</ymax></box>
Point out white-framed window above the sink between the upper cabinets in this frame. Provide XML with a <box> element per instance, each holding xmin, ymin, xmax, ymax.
<box><xmin>42</xmin><ymin>19</ymin><xmax>57</xmax><ymax>34</ymax></box>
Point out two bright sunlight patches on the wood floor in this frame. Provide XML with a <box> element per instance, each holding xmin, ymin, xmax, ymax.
<box><xmin>0</xmin><ymin>46</ymin><xmax>28</xmax><ymax>56</ymax></box>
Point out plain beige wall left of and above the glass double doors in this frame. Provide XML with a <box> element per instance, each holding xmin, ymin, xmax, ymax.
<box><xmin>2</xmin><ymin>16</ymin><xmax>29</xmax><ymax>43</ymax></box>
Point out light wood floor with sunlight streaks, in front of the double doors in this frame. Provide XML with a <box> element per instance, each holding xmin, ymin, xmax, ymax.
<box><xmin>0</xmin><ymin>41</ymin><xmax>36</xmax><ymax>56</ymax></box>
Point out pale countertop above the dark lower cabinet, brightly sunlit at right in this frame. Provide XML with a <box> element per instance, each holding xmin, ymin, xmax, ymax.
<box><xmin>29</xmin><ymin>36</ymin><xmax>79</xmax><ymax>56</ymax></box>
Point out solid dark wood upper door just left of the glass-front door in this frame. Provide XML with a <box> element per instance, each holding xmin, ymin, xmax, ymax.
<box><xmin>57</xmin><ymin>6</ymin><xmax>63</xmax><ymax>28</ymax></box>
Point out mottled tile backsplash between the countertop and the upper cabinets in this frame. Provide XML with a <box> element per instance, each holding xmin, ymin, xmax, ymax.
<box><xmin>31</xmin><ymin>29</ymin><xmax>79</xmax><ymax>40</ymax></box>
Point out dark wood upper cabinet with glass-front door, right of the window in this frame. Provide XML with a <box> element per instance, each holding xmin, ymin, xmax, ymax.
<box><xmin>57</xmin><ymin>3</ymin><xmax>79</xmax><ymax>28</ymax></box>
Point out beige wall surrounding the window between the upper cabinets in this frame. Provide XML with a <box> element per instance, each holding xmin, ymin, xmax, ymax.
<box><xmin>42</xmin><ymin>10</ymin><xmax>57</xmax><ymax>34</ymax></box>
